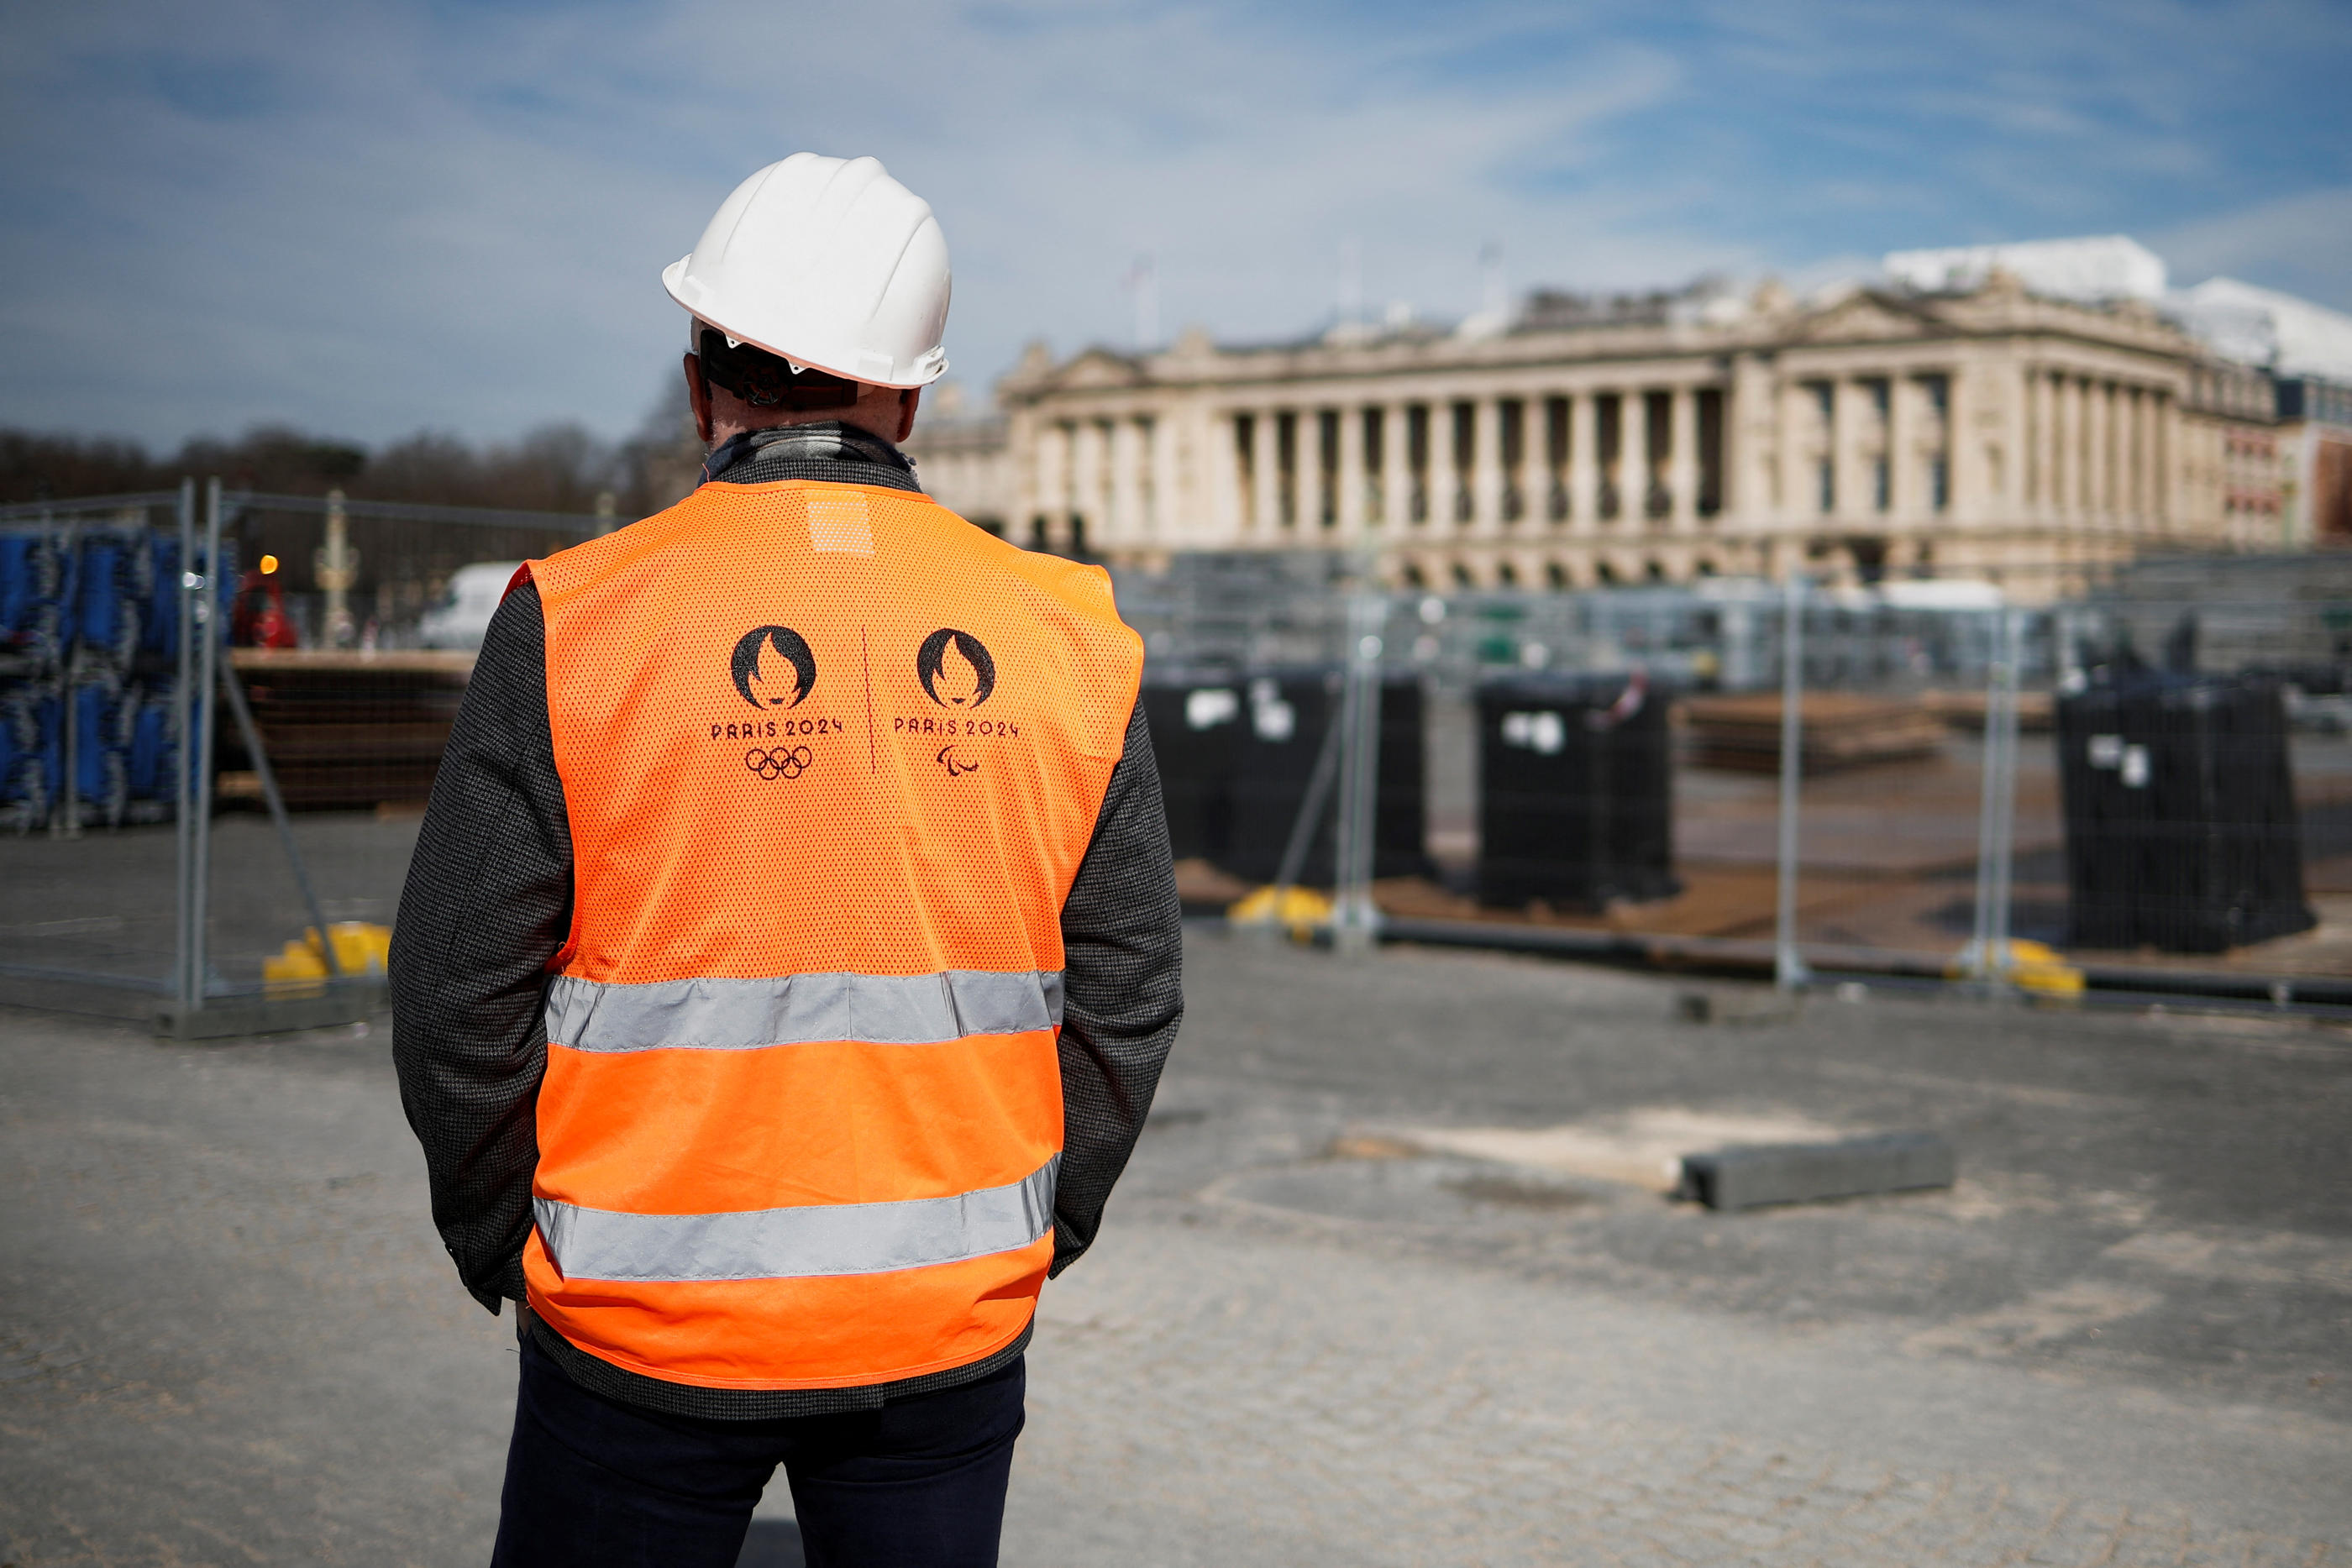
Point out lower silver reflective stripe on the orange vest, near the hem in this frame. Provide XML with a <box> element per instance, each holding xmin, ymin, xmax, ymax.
<box><xmin>532</xmin><ymin>1154</ymin><xmax>1061</xmax><ymax>1282</ymax></box>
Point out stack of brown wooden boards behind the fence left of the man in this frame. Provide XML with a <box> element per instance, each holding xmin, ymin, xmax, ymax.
<box><xmin>218</xmin><ymin>649</ymin><xmax>473</xmax><ymax>809</ymax></box>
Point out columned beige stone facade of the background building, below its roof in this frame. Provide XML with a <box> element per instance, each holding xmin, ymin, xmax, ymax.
<box><xmin>1016</xmin><ymin>343</ymin><xmax>2197</xmax><ymax>588</ymax></box>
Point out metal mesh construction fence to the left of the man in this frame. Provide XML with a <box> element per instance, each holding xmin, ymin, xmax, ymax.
<box><xmin>0</xmin><ymin>480</ymin><xmax>614</xmax><ymax>1035</ymax></box>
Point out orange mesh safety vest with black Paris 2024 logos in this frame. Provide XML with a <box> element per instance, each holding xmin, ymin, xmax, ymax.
<box><xmin>522</xmin><ymin>480</ymin><xmax>1143</xmax><ymax>1389</ymax></box>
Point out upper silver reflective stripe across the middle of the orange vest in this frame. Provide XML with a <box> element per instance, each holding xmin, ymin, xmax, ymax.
<box><xmin>548</xmin><ymin>968</ymin><xmax>1061</xmax><ymax>1051</ymax></box>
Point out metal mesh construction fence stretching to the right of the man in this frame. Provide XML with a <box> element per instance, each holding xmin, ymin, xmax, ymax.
<box><xmin>1120</xmin><ymin>557</ymin><xmax>2352</xmax><ymax>1006</ymax></box>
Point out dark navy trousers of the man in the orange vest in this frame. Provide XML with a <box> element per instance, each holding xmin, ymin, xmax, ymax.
<box><xmin>491</xmin><ymin>1340</ymin><xmax>1028</xmax><ymax>1568</ymax></box>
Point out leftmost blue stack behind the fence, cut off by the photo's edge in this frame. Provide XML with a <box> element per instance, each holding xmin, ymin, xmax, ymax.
<box><xmin>0</xmin><ymin>524</ymin><xmax>76</xmax><ymax>832</ymax></box>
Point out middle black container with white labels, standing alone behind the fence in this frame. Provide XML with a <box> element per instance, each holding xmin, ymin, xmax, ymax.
<box><xmin>1477</xmin><ymin>674</ymin><xmax>1682</xmax><ymax>910</ymax></box>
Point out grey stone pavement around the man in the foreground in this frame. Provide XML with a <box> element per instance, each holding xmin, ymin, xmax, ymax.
<box><xmin>0</xmin><ymin>933</ymin><xmax>2352</xmax><ymax>1568</ymax></box>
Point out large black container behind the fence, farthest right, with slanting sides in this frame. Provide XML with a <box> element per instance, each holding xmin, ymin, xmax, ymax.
<box><xmin>2058</xmin><ymin>673</ymin><xmax>2317</xmax><ymax>952</ymax></box>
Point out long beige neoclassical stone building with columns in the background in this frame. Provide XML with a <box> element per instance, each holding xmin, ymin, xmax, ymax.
<box><xmin>912</xmin><ymin>270</ymin><xmax>2288</xmax><ymax>600</ymax></box>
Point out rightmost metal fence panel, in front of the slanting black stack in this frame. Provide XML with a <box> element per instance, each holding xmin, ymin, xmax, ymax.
<box><xmin>2016</xmin><ymin>580</ymin><xmax>2352</xmax><ymax>1004</ymax></box>
